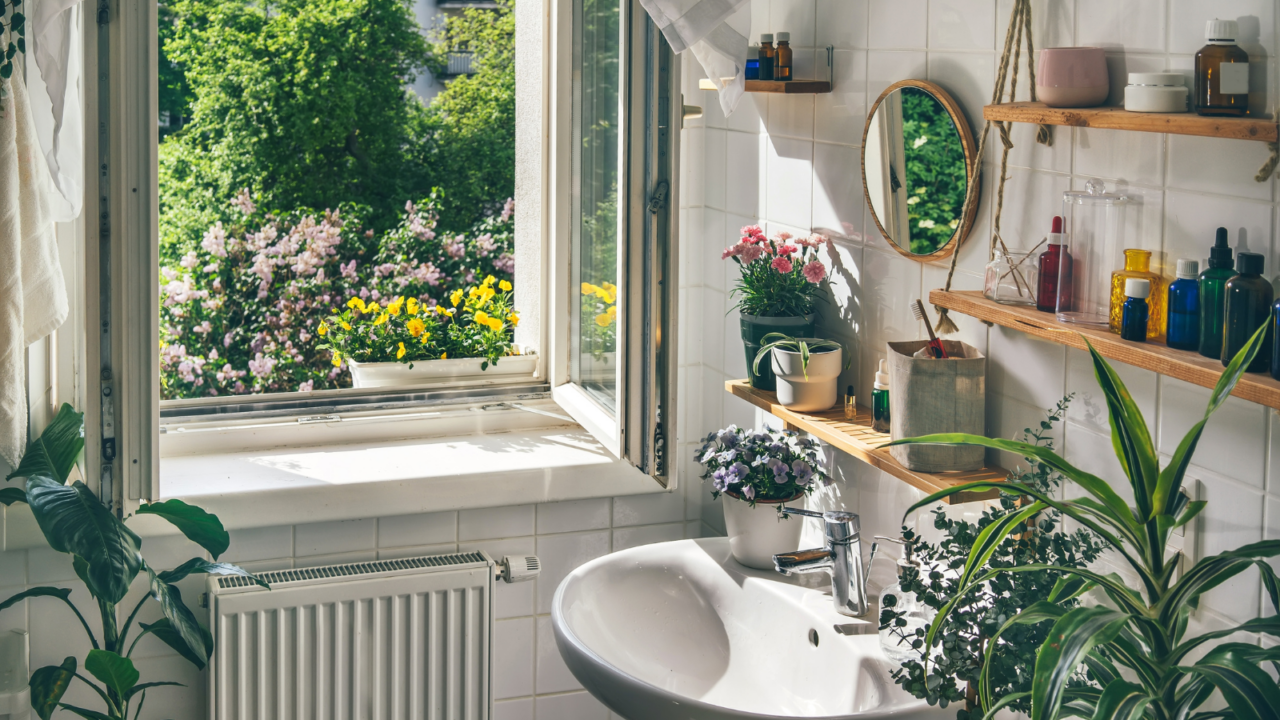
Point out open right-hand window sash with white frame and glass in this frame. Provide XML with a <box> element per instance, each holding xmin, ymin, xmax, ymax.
<box><xmin>548</xmin><ymin>0</ymin><xmax>682</xmax><ymax>484</ymax></box>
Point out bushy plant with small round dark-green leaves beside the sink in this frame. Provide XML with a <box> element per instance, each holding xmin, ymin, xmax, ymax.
<box><xmin>881</xmin><ymin>396</ymin><xmax>1102</xmax><ymax>720</ymax></box>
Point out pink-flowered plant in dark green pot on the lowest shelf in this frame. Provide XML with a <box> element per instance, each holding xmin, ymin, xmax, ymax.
<box><xmin>721</xmin><ymin>225</ymin><xmax>828</xmax><ymax>391</ymax></box>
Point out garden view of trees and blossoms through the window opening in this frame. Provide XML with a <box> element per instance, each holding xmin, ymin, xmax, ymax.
<box><xmin>159</xmin><ymin>0</ymin><xmax>517</xmax><ymax>398</ymax></box>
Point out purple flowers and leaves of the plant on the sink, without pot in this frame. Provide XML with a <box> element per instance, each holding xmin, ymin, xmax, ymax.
<box><xmin>698</xmin><ymin>425</ymin><xmax>828</xmax><ymax>507</ymax></box>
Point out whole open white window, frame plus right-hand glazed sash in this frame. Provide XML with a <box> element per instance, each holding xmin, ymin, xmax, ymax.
<box><xmin>84</xmin><ymin>0</ymin><xmax>681</xmax><ymax>514</ymax></box>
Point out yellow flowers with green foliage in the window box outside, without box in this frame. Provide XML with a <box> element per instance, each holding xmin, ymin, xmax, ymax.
<box><xmin>316</xmin><ymin>275</ymin><xmax>520</xmax><ymax>370</ymax></box>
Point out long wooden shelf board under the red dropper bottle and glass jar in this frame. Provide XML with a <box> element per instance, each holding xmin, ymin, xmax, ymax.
<box><xmin>929</xmin><ymin>290</ymin><xmax>1280</xmax><ymax>409</ymax></box>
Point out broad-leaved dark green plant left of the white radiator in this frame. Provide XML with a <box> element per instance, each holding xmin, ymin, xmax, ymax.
<box><xmin>0</xmin><ymin>405</ymin><xmax>266</xmax><ymax>720</ymax></box>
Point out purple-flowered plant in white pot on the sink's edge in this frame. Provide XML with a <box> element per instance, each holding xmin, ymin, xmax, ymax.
<box><xmin>698</xmin><ymin>425</ymin><xmax>827</xmax><ymax>570</ymax></box>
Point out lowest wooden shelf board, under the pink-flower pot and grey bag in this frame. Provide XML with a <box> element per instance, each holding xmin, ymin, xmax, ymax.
<box><xmin>724</xmin><ymin>380</ymin><xmax>1009</xmax><ymax>503</ymax></box>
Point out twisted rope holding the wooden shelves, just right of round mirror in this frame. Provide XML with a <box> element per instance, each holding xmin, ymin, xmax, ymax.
<box><xmin>934</xmin><ymin>0</ymin><xmax>1053</xmax><ymax>334</ymax></box>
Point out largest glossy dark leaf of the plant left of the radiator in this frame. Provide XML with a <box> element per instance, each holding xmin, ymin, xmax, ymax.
<box><xmin>27</xmin><ymin>477</ymin><xmax>142</xmax><ymax>605</ymax></box>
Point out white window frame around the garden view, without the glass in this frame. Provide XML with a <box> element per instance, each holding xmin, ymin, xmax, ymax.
<box><xmin>83</xmin><ymin>0</ymin><xmax>681</xmax><ymax>514</ymax></box>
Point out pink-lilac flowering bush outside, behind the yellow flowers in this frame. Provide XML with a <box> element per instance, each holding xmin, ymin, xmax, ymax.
<box><xmin>160</xmin><ymin>191</ymin><xmax>515</xmax><ymax>398</ymax></box>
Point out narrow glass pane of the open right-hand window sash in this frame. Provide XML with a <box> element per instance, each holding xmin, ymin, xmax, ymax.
<box><xmin>570</xmin><ymin>0</ymin><xmax>622</xmax><ymax>413</ymax></box>
